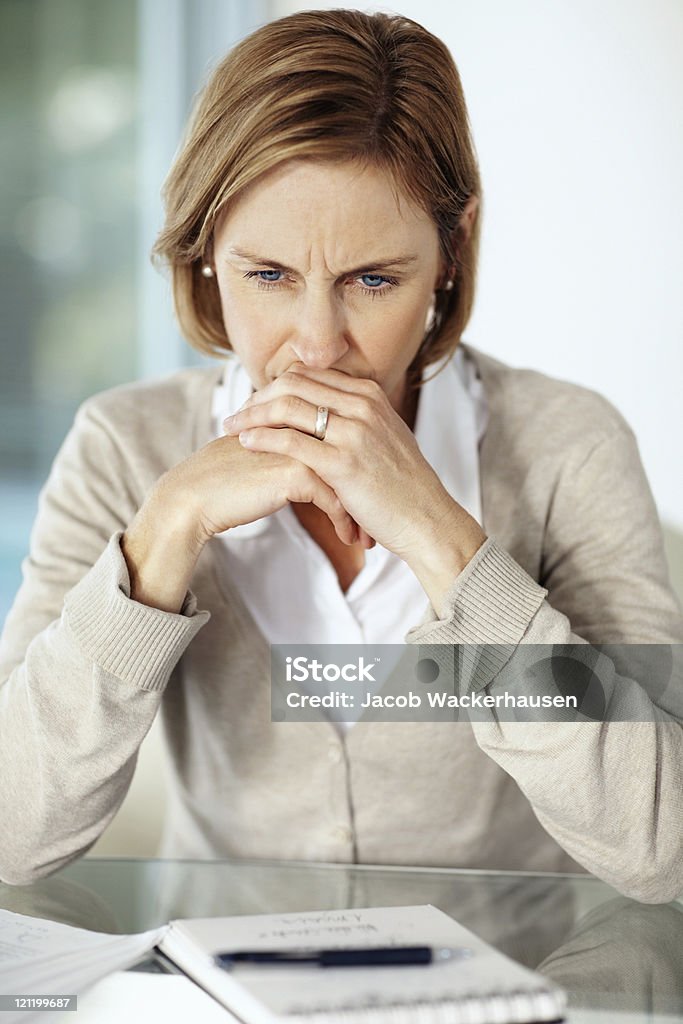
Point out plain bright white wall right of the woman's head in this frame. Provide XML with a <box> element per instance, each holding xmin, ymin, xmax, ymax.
<box><xmin>272</xmin><ymin>0</ymin><xmax>683</xmax><ymax>530</ymax></box>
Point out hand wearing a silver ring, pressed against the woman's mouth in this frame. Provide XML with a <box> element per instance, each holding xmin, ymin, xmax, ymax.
<box><xmin>223</xmin><ymin>362</ymin><xmax>463</xmax><ymax>558</ymax></box>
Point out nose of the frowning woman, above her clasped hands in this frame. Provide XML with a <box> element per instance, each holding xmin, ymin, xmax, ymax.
<box><xmin>291</xmin><ymin>289</ymin><xmax>349</xmax><ymax>370</ymax></box>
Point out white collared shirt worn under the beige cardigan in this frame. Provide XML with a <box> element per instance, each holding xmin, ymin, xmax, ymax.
<box><xmin>212</xmin><ymin>349</ymin><xmax>487</xmax><ymax>644</ymax></box>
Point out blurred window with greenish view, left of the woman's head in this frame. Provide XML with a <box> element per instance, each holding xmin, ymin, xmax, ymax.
<box><xmin>0</xmin><ymin>0</ymin><xmax>267</xmax><ymax>624</ymax></box>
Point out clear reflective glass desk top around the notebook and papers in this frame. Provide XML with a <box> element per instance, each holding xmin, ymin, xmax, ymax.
<box><xmin>0</xmin><ymin>858</ymin><xmax>683</xmax><ymax>1024</ymax></box>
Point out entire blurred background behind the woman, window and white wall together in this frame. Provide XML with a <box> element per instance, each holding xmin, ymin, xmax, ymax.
<box><xmin>0</xmin><ymin>0</ymin><xmax>683</xmax><ymax>853</ymax></box>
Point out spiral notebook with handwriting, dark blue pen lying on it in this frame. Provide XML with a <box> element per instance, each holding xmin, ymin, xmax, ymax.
<box><xmin>159</xmin><ymin>906</ymin><xmax>566</xmax><ymax>1024</ymax></box>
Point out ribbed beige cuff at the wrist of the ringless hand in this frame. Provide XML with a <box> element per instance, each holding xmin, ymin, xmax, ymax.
<box><xmin>65</xmin><ymin>530</ymin><xmax>211</xmax><ymax>690</ymax></box>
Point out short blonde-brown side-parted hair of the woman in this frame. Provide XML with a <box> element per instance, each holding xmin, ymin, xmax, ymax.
<box><xmin>153</xmin><ymin>10</ymin><xmax>481</xmax><ymax>386</ymax></box>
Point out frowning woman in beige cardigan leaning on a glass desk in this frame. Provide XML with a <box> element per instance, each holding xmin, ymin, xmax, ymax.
<box><xmin>0</xmin><ymin>10</ymin><xmax>683</xmax><ymax>901</ymax></box>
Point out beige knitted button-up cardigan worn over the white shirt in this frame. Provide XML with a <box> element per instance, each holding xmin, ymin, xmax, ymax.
<box><xmin>0</xmin><ymin>349</ymin><xmax>683</xmax><ymax>902</ymax></box>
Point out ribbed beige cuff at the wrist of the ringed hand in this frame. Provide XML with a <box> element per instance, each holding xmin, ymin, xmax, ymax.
<box><xmin>405</xmin><ymin>538</ymin><xmax>548</xmax><ymax>689</ymax></box>
